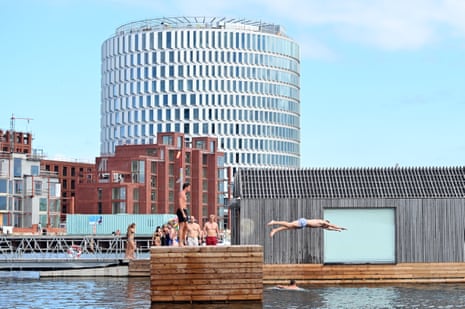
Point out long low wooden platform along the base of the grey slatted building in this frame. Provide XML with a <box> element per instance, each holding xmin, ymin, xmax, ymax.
<box><xmin>263</xmin><ymin>263</ymin><xmax>465</xmax><ymax>284</ymax></box>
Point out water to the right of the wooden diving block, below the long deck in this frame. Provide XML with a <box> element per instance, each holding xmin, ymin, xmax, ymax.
<box><xmin>263</xmin><ymin>284</ymin><xmax>465</xmax><ymax>309</ymax></box>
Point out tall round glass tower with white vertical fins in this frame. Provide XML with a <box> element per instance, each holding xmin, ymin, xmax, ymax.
<box><xmin>101</xmin><ymin>17</ymin><xmax>300</xmax><ymax>168</ymax></box>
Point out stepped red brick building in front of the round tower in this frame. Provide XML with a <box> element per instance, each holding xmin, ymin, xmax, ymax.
<box><xmin>75</xmin><ymin>132</ymin><xmax>227</xmax><ymax>221</ymax></box>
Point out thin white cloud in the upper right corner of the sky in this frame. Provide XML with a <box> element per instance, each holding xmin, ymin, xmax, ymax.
<box><xmin>252</xmin><ymin>0</ymin><xmax>465</xmax><ymax>50</ymax></box>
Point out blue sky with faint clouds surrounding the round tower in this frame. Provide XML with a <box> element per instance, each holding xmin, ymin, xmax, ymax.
<box><xmin>0</xmin><ymin>0</ymin><xmax>465</xmax><ymax>167</ymax></box>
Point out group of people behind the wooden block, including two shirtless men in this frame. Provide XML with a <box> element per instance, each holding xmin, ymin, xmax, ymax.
<box><xmin>152</xmin><ymin>215</ymin><xmax>220</xmax><ymax>247</ymax></box>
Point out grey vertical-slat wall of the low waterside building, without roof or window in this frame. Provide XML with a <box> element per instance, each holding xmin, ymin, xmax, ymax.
<box><xmin>240</xmin><ymin>199</ymin><xmax>465</xmax><ymax>264</ymax></box>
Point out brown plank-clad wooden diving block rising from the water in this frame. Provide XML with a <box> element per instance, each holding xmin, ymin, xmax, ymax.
<box><xmin>150</xmin><ymin>246</ymin><xmax>263</xmax><ymax>303</ymax></box>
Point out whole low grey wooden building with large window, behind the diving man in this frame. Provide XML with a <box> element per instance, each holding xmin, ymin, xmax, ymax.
<box><xmin>231</xmin><ymin>167</ymin><xmax>465</xmax><ymax>264</ymax></box>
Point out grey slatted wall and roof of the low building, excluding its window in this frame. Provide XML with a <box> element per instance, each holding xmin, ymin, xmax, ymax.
<box><xmin>231</xmin><ymin>167</ymin><xmax>465</xmax><ymax>264</ymax></box>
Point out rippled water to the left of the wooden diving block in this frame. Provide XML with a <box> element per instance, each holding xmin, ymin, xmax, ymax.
<box><xmin>0</xmin><ymin>277</ymin><xmax>150</xmax><ymax>308</ymax></box>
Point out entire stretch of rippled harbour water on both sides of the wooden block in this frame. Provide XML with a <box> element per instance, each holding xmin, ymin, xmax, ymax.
<box><xmin>0</xmin><ymin>278</ymin><xmax>465</xmax><ymax>309</ymax></box>
